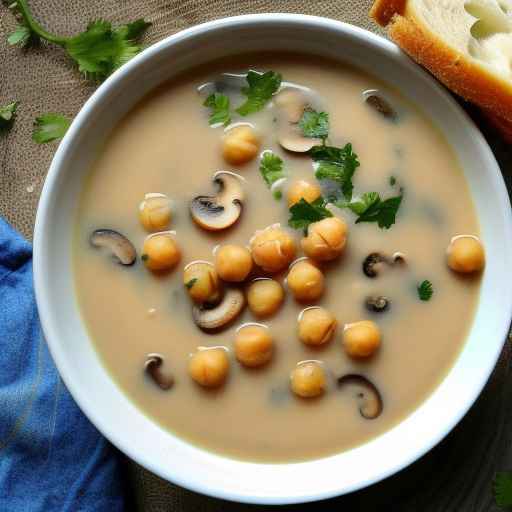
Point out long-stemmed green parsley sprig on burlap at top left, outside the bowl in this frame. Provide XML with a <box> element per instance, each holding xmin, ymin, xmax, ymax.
<box><xmin>8</xmin><ymin>0</ymin><xmax>151</xmax><ymax>80</ymax></box>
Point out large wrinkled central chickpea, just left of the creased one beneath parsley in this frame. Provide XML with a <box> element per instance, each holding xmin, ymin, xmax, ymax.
<box><xmin>251</xmin><ymin>226</ymin><xmax>296</xmax><ymax>272</ymax></box>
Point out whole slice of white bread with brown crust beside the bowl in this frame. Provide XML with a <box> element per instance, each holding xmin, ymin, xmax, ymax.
<box><xmin>370</xmin><ymin>0</ymin><xmax>512</xmax><ymax>124</ymax></box>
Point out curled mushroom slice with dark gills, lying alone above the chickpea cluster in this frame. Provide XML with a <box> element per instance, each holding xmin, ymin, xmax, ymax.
<box><xmin>190</xmin><ymin>171</ymin><xmax>244</xmax><ymax>231</ymax></box>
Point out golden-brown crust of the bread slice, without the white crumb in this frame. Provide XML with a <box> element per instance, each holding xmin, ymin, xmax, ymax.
<box><xmin>370</xmin><ymin>0</ymin><xmax>512</xmax><ymax>122</ymax></box>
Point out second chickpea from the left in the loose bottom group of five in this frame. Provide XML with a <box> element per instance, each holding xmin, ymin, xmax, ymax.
<box><xmin>235</xmin><ymin>324</ymin><xmax>274</xmax><ymax>368</ymax></box>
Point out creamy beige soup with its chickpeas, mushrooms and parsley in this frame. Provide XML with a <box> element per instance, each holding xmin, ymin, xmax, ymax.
<box><xmin>74</xmin><ymin>55</ymin><xmax>483</xmax><ymax>462</ymax></box>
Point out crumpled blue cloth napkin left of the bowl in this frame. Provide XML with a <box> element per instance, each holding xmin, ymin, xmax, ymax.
<box><xmin>0</xmin><ymin>218</ymin><xmax>125</xmax><ymax>512</ymax></box>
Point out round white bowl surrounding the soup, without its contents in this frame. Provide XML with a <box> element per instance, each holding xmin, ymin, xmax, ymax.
<box><xmin>34</xmin><ymin>14</ymin><xmax>512</xmax><ymax>504</ymax></box>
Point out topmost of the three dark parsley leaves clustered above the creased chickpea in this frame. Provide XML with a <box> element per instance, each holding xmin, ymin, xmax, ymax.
<box><xmin>309</xmin><ymin>144</ymin><xmax>360</xmax><ymax>201</ymax></box>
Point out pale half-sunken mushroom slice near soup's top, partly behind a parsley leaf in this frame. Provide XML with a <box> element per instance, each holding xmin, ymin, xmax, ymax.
<box><xmin>274</xmin><ymin>86</ymin><xmax>322</xmax><ymax>153</ymax></box>
